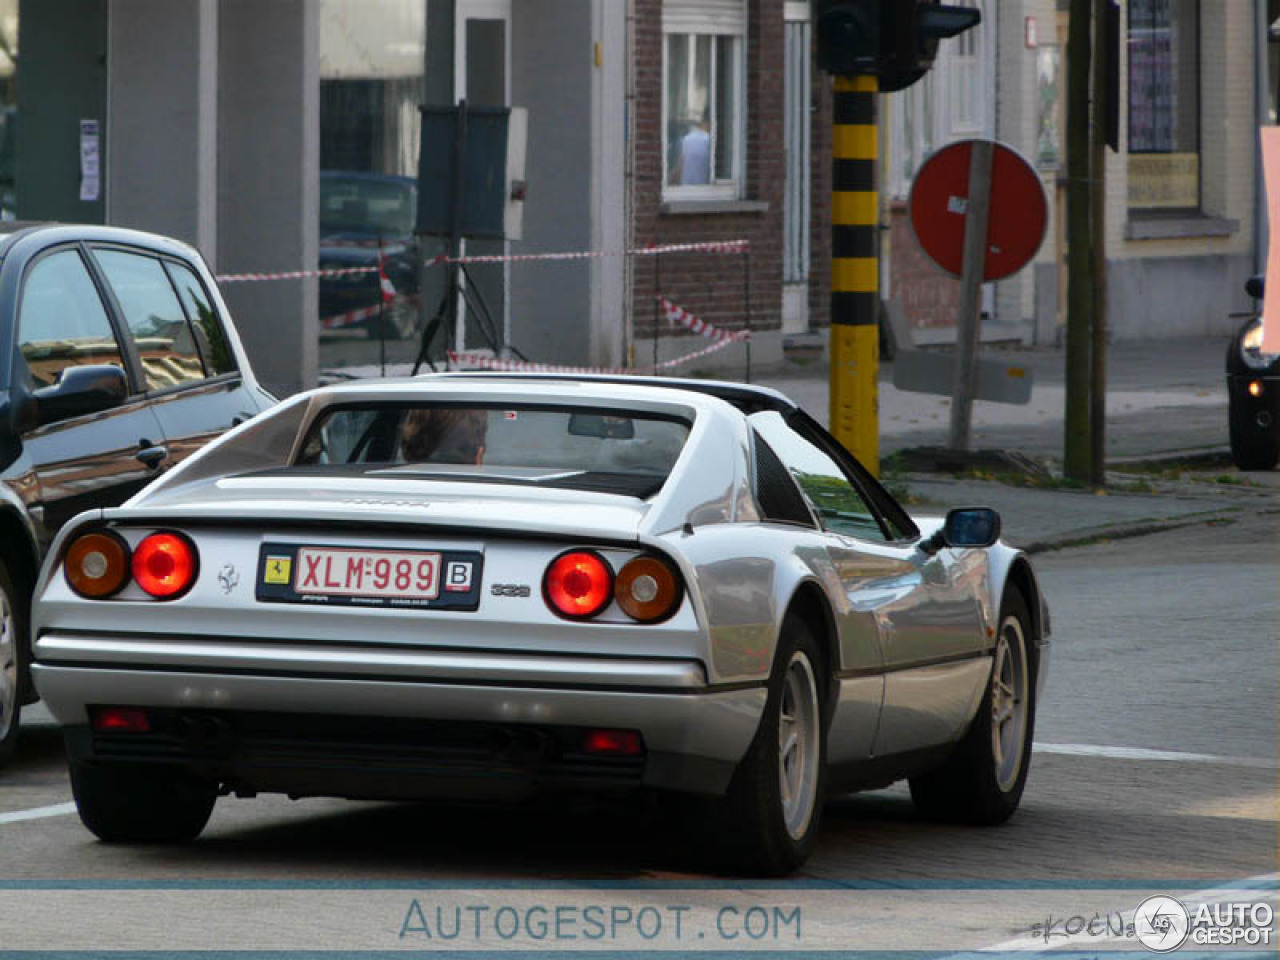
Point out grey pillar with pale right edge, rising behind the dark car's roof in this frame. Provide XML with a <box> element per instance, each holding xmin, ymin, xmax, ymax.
<box><xmin>106</xmin><ymin>0</ymin><xmax>218</xmax><ymax>264</ymax></box>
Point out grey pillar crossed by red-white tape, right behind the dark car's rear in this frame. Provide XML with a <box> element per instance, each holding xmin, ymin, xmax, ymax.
<box><xmin>218</xmin><ymin>0</ymin><xmax>320</xmax><ymax>396</ymax></box>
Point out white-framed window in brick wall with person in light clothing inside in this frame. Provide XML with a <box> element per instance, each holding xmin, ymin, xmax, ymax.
<box><xmin>662</xmin><ymin>0</ymin><xmax>746</xmax><ymax>200</ymax></box>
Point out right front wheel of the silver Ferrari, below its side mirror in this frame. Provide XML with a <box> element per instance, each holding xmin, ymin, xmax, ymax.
<box><xmin>911</xmin><ymin>590</ymin><xmax>1036</xmax><ymax>826</ymax></box>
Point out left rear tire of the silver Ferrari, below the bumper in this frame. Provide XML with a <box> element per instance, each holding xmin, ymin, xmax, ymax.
<box><xmin>70</xmin><ymin>760</ymin><xmax>218</xmax><ymax>844</ymax></box>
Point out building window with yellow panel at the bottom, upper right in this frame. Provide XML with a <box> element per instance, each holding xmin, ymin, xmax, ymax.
<box><xmin>1128</xmin><ymin>0</ymin><xmax>1201</xmax><ymax>212</ymax></box>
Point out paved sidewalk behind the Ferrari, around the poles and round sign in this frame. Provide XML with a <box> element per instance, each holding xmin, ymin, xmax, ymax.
<box><xmin>756</xmin><ymin>338</ymin><xmax>1280</xmax><ymax>550</ymax></box>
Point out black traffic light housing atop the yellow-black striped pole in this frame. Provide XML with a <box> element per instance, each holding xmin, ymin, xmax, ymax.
<box><xmin>814</xmin><ymin>0</ymin><xmax>982</xmax><ymax>93</ymax></box>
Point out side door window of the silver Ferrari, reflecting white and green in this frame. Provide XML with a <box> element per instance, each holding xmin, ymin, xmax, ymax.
<box><xmin>750</xmin><ymin>410</ymin><xmax>887</xmax><ymax>540</ymax></box>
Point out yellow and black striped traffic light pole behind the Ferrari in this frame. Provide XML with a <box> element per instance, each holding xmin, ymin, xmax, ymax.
<box><xmin>829</xmin><ymin>77</ymin><xmax>879</xmax><ymax>475</ymax></box>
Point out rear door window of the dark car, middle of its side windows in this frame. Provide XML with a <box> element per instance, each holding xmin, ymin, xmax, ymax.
<box><xmin>93</xmin><ymin>250</ymin><xmax>205</xmax><ymax>390</ymax></box>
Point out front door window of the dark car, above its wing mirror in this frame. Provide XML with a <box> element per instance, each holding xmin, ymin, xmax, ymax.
<box><xmin>18</xmin><ymin>250</ymin><xmax>125</xmax><ymax>387</ymax></box>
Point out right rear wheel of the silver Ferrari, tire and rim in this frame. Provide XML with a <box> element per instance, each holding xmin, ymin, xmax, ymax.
<box><xmin>707</xmin><ymin>617</ymin><xmax>827</xmax><ymax>877</ymax></box>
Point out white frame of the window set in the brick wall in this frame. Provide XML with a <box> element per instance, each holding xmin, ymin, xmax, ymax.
<box><xmin>658</xmin><ymin>0</ymin><xmax>750</xmax><ymax>202</ymax></box>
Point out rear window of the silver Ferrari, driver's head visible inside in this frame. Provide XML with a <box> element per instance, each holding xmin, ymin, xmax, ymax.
<box><xmin>294</xmin><ymin>403</ymin><xmax>689</xmax><ymax>498</ymax></box>
